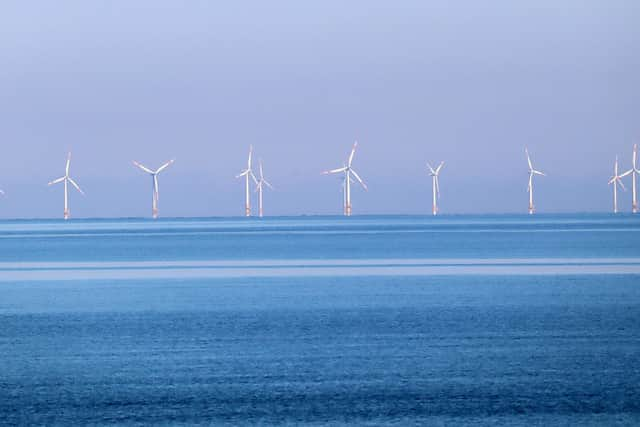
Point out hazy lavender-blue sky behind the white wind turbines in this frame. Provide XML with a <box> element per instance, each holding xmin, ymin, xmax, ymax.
<box><xmin>0</xmin><ymin>0</ymin><xmax>640</xmax><ymax>218</ymax></box>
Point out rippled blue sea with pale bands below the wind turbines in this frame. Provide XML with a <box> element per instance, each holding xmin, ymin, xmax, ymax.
<box><xmin>0</xmin><ymin>214</ymin><xmax>640</xmax><ymax>426</ymax></box>
